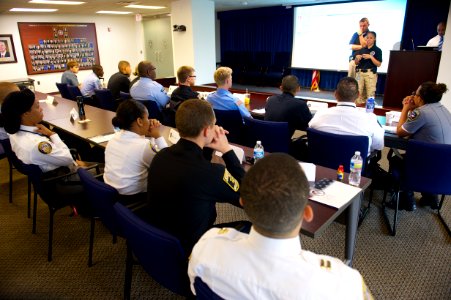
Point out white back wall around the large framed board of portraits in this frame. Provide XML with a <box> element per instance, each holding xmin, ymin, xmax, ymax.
<box><xmin>0</xmin><ymin>14</ymin><xmax>144</xmax><ymax>93</ymax></box>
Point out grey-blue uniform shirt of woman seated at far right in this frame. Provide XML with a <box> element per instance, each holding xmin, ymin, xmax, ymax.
<box><xmin>402</xmin><ymin>102</ymin><xmax>451</xmax><ymax>144</ymax></box>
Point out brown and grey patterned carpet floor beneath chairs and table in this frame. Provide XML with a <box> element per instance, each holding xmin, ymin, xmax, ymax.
<box><xmin>0</xmin><ymin>150</ymin><xmax>451</xmax><ymax>299</ymax></box>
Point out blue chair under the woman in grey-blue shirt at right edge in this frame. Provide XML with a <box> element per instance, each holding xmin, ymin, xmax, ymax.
<box><xmin>383</xmin><ymin>140</ymin><xmax>451</xmax><ymax>236</ymax></box>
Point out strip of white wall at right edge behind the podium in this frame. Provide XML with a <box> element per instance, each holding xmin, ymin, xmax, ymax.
<box><xmin>437</xmin><ymin>6</ymin><xmax>451</xmax><ymax>111</ymax></box>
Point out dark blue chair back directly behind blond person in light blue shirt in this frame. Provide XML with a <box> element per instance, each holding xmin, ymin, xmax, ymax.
<box><xmin>214</xmin><ymin>109</ymin><xmax>244</xmax><ymax>145</ymax></box>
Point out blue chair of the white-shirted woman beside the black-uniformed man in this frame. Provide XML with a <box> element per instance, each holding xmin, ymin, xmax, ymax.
<box><xmin>77</xmin><ymin>168</ymin><xmax>121</xmax><ymax>267</ymax></box>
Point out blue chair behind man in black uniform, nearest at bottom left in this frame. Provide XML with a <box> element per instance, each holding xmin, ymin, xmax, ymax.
<box><xmin>114</xmin><ymin>202</ymin><xmax>191</xmax><ymax>299</ymax></box>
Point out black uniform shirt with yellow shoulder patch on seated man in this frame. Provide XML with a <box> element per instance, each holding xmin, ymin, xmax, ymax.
<box><xmin>146</xmin><ymin>138</ymin><xmax>244</xmax><ymax>253</ymax></box>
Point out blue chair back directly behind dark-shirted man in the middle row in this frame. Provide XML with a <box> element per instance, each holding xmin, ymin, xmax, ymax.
<box><xmin>243</xmin><ymin>117</ymin><xmax>291</xmax><ymax>153</ymax></box>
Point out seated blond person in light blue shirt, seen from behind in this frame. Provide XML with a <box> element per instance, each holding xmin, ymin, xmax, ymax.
<box><xmin>207</xmin><ymin>67</ymin><xmax>251</xmax><ymax>118</ymax></box>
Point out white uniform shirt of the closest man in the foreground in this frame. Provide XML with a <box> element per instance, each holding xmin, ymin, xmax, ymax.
<box><xmin>188</xmin><ymin>228</ymin><xmax>370</xmax><ymax>300</ymax></box>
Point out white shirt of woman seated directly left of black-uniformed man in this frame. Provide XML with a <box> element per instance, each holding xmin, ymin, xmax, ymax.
<box><xmin>103</xmin><ymin>130</ymin><xmax>168</xmax><ymax>195</ymax></box>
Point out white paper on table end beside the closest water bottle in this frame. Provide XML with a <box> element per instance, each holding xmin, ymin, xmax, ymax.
<box><xmin>310</xmin><ymin>181</ymin><xmax>362</xmax><ymax>208</ymax></box>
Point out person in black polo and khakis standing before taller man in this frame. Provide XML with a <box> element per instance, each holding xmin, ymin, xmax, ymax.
<box><xmin>354</xmin><ymin>31</ymin><xmax>382</xmax><ymax>104</ymax></box>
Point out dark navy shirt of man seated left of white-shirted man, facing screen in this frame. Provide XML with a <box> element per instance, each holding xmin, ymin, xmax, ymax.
<box><xmin>265</xmin><ymin>92</ymin><xmax>312</xmax><ymax>136</ymax></box>
